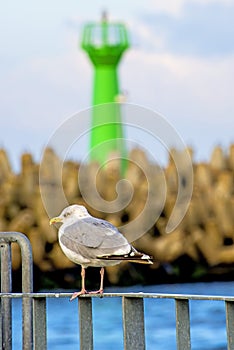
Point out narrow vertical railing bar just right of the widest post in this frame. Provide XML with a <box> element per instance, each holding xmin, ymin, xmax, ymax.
<box><xmin>175</xmin><ymin>299</ymin><xmax>191</xmax><ymax>350</ymax></box>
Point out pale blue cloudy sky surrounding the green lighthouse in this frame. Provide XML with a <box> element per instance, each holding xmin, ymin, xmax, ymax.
<box><xmin>0</xmin><ymin>0</ymin><xmax>234</xmax><ymax>172</ymax></box>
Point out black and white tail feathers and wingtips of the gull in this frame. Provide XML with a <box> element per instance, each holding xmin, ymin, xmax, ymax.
<box><xmin>97</xmin><ymin>249</ymin><xmax>153</xmax><ymax>264</ymax></box>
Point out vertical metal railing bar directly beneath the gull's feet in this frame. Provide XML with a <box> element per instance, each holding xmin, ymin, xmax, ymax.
<box><xmin>78</xmin><ymin>297</ymin><xmax>93</xmax><ymax>350</ymax></box>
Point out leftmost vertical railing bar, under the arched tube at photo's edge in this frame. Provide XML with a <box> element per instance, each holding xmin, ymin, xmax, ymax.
<box><xmin>0</xmin><ymin>240</ymin><xmax>12</xmax><ymax>350</ymax></box>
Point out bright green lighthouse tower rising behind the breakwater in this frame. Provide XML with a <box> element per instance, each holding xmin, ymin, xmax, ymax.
<box><xmin>82</xmin><ymin>14</ymin><xmax>129</xmax><ymax>170</ymax></box>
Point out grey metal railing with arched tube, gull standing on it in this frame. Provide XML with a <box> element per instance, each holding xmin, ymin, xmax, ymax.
<box><xmin>0</xmin><ymin>233</ymin><xmax>234</xmax><ymax>350</ymax></box>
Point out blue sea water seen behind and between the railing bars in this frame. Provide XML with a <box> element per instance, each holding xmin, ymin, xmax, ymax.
<box><xmin>13</xmin><ymin>282</ymin><xmax>234</xmax><ymax>350</ymax></box>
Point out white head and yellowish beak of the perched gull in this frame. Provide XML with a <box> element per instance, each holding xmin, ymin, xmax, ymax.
<box><xmin>50</xmin><ymin>204</ymin><xmax>90</xmax><ymax>225</ymax></box>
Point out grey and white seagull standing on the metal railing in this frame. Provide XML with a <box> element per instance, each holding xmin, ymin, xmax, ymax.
<box><xmin>50</xmin><ymin>204</ymin><xmax>153</xmax><ymax>300</ymax></box>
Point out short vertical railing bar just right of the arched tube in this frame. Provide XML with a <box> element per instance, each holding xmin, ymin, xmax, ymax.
<box><xmin>33</xmin><ymin>297</ymin><xmax>47</xmax><ymax>350</ymax></box>
